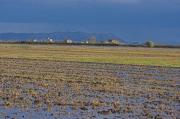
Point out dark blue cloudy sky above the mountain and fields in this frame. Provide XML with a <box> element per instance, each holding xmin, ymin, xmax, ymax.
<box><xmin>0</xmin><ymin>0</ymin><xmax>180</xmax><ymax>44</ymax></box>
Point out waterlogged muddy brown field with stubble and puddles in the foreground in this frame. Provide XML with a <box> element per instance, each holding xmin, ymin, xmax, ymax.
<box><xmin>0</xmin><ymin>58</ymin><xmax>180</xmax><ymax>119</ymax></box>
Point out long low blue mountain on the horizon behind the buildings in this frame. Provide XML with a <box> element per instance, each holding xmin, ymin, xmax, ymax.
<box><xmin>0</xmin><ymin>32</ymin><xmax>123</xmax><ymax>42</ymax></box>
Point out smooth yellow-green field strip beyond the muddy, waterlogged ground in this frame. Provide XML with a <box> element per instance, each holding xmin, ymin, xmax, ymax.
<box><xmin>0</xmin><ymin>44</ymin><xmax>180</xmax><ymax>67</ymax></box>
